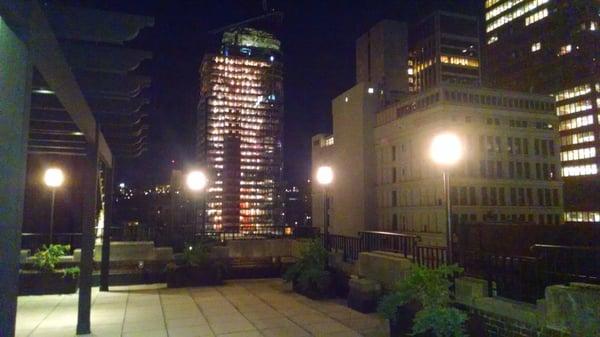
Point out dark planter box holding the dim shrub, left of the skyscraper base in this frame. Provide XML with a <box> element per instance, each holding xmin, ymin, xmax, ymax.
<box><xmin>166</xmin><ymin>266</ymin><xmax>223</xmax><ymax>288</ymax></box>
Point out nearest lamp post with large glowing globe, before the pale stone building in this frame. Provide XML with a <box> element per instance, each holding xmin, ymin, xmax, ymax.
<box><xmin>430</xmin><ymin>132</ymin><xmax>463</xmax><ymax>264</ymax></box>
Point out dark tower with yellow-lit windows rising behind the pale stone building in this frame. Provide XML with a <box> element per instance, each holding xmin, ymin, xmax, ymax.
<box><xmin>408</xmin><ymin>11</ymin><xmax>481</xmax><ymax>93</ymax></box>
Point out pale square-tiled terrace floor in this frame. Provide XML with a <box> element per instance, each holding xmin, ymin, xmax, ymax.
<box><xmin>17</xmin><ymin>279</ymin><xmax>387</xmax><ymax>337</ymax></box>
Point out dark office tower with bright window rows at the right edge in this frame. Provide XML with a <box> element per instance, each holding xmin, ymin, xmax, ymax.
<box><xmin>485</xmin><ymin>0</ymin><xmax>600</xmax><ymax>223</ymax></box>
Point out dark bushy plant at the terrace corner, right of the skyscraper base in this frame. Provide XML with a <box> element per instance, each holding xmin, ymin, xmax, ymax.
<box><xmin>283</xmin><ymin>239</ymin><xmax>333</xmax><ymax>299</ymax></box>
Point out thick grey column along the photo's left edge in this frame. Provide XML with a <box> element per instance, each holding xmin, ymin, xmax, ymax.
<box><xmin>0</xmin><ymin>16</ymin><xmax>32</xmax><ymax>337</ymax></box>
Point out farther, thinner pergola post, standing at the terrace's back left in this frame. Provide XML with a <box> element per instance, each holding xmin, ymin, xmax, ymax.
<box><xmin>100</xmin><ymin>160</ymin><xmax>115</xmax><ymax>291</ymax></box>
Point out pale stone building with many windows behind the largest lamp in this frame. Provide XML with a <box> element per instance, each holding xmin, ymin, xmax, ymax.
<box><xmin>374</xmin><ymin>85</ymin><xmax>563</xmax><ymax>246</ymax></box>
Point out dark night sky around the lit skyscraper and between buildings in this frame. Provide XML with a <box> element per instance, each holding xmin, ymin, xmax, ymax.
<box><xmin>78</xmin><ymin>0</ymin><xmax>483</xmax><ymax>185</ymax></box>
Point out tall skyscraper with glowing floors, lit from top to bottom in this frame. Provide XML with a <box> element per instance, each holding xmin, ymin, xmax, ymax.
<box><xmin>197</xmin><ymin>27</ymin><xmax>283</xmax><ymax>231</ymax></box>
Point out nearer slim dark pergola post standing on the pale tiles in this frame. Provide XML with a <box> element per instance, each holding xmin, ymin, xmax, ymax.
<box><xmin>77</xmin><ymin>137</ymin><xmax>98</xmax><ymax>335</ymax></box>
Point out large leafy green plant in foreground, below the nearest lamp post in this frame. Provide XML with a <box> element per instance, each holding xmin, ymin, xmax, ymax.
<box><xmin>377</xmin><ymin>265</ymin><xmax>468</xmax><ymax>337</ymax></box>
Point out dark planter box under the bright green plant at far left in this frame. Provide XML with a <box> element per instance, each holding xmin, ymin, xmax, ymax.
<box><xmin>19</xmin><ymin>270</ymin><xmax>79</xmax><ymax>295</ymax></box>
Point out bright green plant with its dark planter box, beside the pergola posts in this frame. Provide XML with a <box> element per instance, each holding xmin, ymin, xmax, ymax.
<box><xmin>19</xmin><ymin>244</ymin><xmax>79</xmax><ymax>295</ymax></box>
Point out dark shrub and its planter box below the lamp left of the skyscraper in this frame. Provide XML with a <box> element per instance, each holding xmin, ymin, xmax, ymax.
<box><xmin>166</xmin><ymin>241</ymin><xmax>225</xmax><ymax>288</ymax></box>
